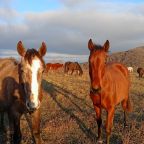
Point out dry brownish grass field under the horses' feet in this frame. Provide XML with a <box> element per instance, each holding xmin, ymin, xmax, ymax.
<box><xmin>1</xmin><ymin>70</ymin><xmax>144</xmax><ymax>144</ymax></box>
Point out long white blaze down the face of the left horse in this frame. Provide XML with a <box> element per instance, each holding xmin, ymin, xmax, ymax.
<box><xmin>31</xmin><ymin>59</ymin><xmax>40</xmax><ymax>107</ymax></box>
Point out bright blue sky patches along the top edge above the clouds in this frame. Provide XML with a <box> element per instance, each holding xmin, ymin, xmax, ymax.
<box><xmin>7</xmin><ymin>0</ymin><xmax>143</xmax><ymax>12</ymax></box>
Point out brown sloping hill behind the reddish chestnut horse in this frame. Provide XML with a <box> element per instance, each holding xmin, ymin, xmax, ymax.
<box><xmin>83</xmin><ymin>46</ymin><xmax>144</xmax><ymax>69</ymax></box>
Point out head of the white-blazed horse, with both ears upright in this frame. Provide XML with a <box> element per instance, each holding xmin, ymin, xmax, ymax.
<box><xmin>17</xmin><ymin>41</ymin><xmax>46</xmax><ymax>112</ymax></box>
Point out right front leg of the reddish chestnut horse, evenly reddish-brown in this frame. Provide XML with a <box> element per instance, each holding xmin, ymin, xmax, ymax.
<box><xmin>106</xmin><ymin>108</ymin><xmax>114</xmax><ymax>144</ymax></box>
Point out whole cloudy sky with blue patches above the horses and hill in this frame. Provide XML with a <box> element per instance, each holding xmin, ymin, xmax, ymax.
<box><xmin>0</xmin><ymin>0</ymin><xmax>144</xmax><ymax>61</ymax></box>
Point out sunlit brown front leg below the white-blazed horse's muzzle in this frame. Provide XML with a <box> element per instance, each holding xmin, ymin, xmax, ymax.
<box><xmin>31</xmin><ymin>109</ymin><xmax>42</xmax><ymax>144</ymax></box>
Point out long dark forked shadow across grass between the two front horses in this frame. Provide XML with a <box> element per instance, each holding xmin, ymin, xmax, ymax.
<box><xmin>42</xmin><ymin>80</ymin><xmax>97</xmax><ymax>143</ymax></box>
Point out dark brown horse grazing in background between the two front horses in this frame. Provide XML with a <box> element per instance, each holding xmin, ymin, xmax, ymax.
<box><xmin>64</xmin><ymin>62</ymin><xmax>83</xmax><ymax>75</ymax></box>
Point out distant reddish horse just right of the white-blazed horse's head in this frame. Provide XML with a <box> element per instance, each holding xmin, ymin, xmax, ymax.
<box><xmin>46</xmin><ymin>63</ymin><xmax>63</xmax><ymax>72</ymax></box>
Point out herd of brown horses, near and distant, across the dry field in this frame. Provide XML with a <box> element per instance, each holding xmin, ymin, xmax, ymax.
<box><xmin>0</xmin><ymin>39</ymin><xmax>143</xmax><ymax>144</ymax></box>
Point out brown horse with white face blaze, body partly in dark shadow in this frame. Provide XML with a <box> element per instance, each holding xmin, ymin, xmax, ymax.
<box><xmin>0</xmin><ymin>41</ymin><xmax>46</xmax><ymax>144</ymax></box>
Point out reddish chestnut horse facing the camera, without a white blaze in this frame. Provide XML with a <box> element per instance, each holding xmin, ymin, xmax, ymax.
<box><xmin>88</xmin><ymin>39</ymin><xmax>132</xmax><ymax>144</ymax></box>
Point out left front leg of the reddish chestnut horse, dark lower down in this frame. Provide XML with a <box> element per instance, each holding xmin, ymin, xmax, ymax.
<box><xmin>94</xmin><ymin>105</ymin><xmax>102</xmax><ymax>143</ymax></box>
